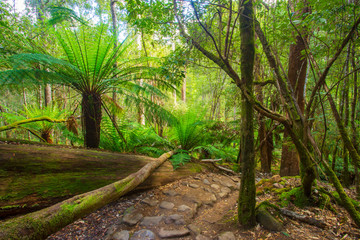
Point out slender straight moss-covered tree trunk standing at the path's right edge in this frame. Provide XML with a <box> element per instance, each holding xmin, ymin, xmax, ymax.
<box><xmin>238</xmin><ymin>0</ymin><xmax>256</xmax><ymax>227</ymax></box>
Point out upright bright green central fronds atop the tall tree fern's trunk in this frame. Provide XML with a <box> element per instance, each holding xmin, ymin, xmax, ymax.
<box><xmin>56</xmin><ymin>26</ymin><xmax>129</xmax><ymax>94</ymax></box>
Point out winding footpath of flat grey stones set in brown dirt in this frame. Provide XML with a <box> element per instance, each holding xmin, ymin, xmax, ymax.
<box><xmin>105</xmin><ymin>173</ymin><xmax>240</xmax><ymax>240</ymax></box>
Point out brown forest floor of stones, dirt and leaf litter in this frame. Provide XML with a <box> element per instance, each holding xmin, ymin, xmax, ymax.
<box><xmin>48</xmin><ymin>172</ymin><xmax>360</xmax><ymax>240</ymax></box>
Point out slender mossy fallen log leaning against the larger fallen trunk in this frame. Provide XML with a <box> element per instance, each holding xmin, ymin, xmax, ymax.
<box><xmin>0</xmin><ymin>151</ymin><xmax>174</xmax><ymax>240</ymax></box>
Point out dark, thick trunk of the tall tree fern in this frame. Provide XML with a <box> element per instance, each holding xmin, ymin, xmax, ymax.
<box><xmin>81</xmin><ymin>93</ymin><xmax>101</xmax><ymax>148</ymax></box>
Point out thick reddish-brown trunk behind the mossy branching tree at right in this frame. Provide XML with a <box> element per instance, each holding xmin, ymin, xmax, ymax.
<box><xmin>280</xmin><ymin>1</ymin><xmax>310</xmax><ymax>176</ymax></box>
